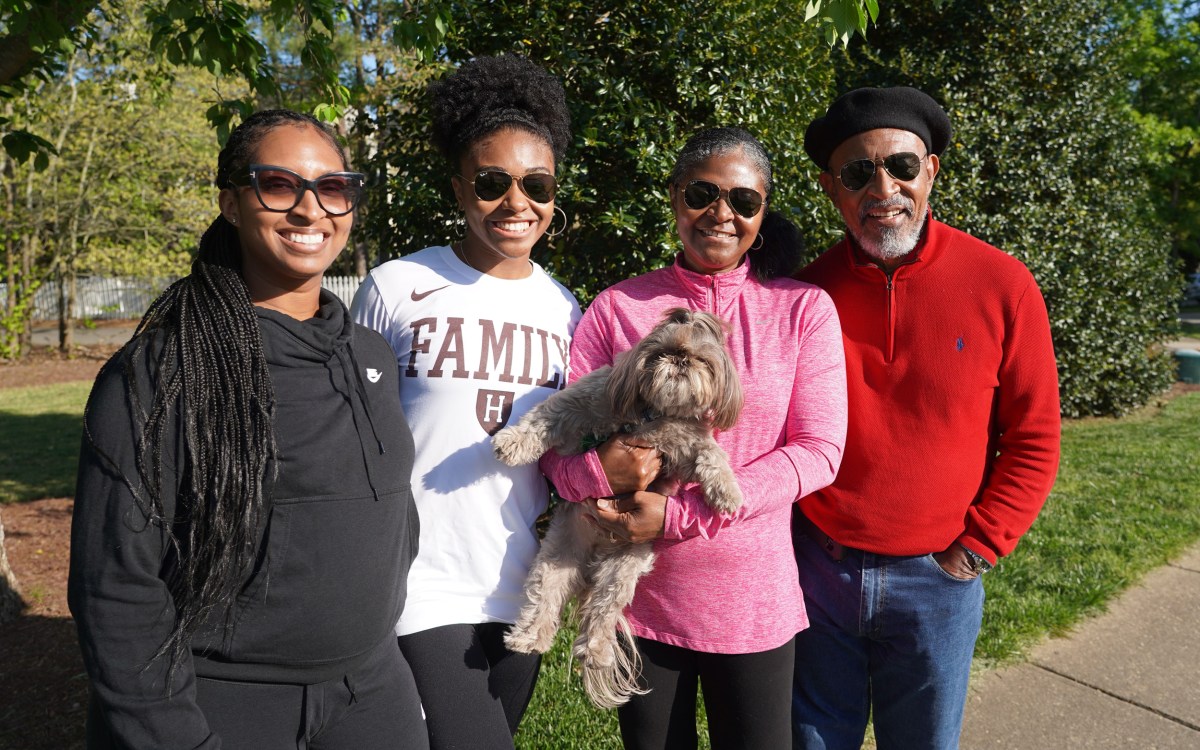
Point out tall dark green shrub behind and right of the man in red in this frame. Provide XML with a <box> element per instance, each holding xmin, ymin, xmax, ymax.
<box><xmin>838</xmin><ymin>0</ymin><xmax>1178</xmax><ymax>416</ymax></box>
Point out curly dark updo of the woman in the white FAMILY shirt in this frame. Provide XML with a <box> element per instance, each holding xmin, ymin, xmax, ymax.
<box><xmin>430</xmin><ymin>54</ymin><xmax>571</xmax><ymax>169</ymax></box>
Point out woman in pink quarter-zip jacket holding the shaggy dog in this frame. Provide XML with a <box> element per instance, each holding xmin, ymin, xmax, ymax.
<box><xmin>542</xmin><ymin>127</ymin><xmax>846</xmax><ymax>749</ymax></box>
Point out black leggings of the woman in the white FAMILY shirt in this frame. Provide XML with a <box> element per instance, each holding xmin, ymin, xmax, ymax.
<box><xmin>397</xmin><ymin>623</ymin><xmax>540</xmax><ymax>750</ymax></box>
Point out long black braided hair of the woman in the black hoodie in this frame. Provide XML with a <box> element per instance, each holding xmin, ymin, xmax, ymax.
<box><xmin>96</xmin><ymin>109</ymin><xmax>344</xmax><ymax>672</ymax></box>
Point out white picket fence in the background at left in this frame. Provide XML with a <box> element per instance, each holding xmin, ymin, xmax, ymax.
<box><xmin>0</xmin><ymin>276</ymin><xmax>362</xmax><ymax>320</ymax></box>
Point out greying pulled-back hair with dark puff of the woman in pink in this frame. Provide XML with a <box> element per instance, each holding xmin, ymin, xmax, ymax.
<box><xmin>671</xmin><ymin>127</ymin><xmax>804</xmax><ymax>281</ymax></box>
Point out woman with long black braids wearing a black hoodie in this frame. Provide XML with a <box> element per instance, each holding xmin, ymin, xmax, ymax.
<box><xmin>68</xmin><ymin>110</ymin><xmax>426</xmax><ymax>750</ymax></box>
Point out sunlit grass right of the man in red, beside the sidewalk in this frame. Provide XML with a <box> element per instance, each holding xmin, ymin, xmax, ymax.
<box><xmin>976</xmin><ymin>392</ymin><xmax>1200</xmax><ymax>661</ymax></box>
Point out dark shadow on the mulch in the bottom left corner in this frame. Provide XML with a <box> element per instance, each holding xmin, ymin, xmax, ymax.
<box><xmin>0</xmin><ymin>616</ymin><xmax>88</xmax><ymax>750</ymax></box>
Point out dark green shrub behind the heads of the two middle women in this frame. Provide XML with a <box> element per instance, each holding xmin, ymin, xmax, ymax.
<box><xmin>367</xmin><ymin>0</ymin><xmax>834</xmax><ymax>301</ymax></box>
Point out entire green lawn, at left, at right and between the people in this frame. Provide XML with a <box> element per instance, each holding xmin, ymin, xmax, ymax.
<box><xmin>0</xmin><ymin>383</ymin><xmax>1200</xmax><ymax>750</ymax></box>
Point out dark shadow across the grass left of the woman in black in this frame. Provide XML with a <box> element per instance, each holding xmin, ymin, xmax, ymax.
<box><xmin>0</xmin><ymin>412</ymin><xmax>83</xmax><ymax>503</ymax></box>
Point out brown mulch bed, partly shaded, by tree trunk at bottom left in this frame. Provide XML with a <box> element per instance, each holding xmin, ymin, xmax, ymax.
<box><xmin>0</xmin><ymin>498</ymin><xmax>88</xmax><ymax>750</ymax></box>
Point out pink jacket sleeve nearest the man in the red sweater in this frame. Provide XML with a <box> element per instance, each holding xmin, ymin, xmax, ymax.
<box><xmin>664</xmin><ymin>286</ymin><xmax>846</xmax><ymax>539</ymax></box>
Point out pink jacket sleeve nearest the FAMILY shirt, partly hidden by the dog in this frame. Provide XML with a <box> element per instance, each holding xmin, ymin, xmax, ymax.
<box><xmin>538</xmin><ymin>295</ymin><xmax>612</xmax><ymax>502</ymax></box>
